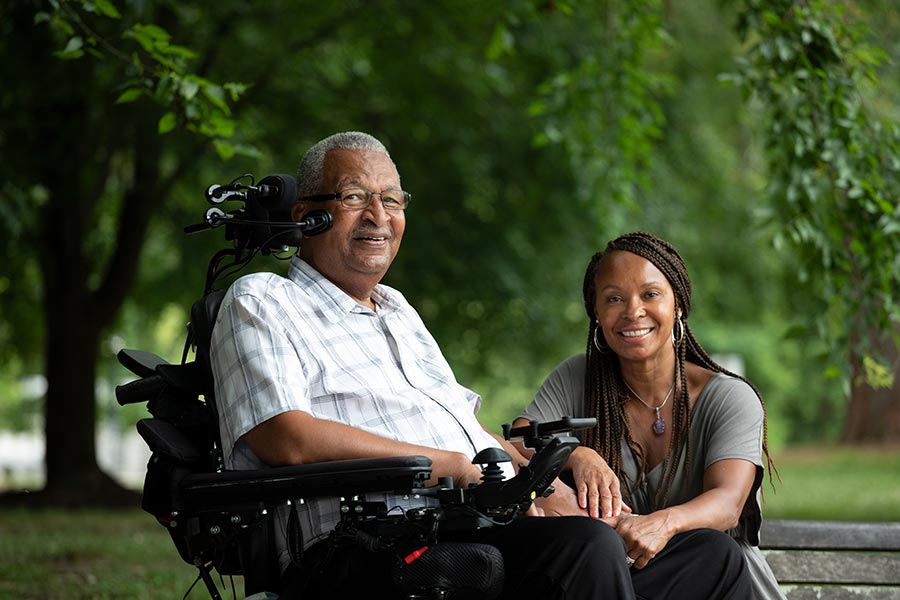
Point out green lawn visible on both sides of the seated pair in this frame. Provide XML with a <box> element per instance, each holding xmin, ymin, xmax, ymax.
<box><xmin>0</xmin><ymin>447</ymin><xmax>900</xmax><ymax>600</ymax></box>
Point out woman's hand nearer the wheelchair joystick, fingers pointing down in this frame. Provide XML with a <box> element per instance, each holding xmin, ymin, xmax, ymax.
<box><xmin>569</xmin><ymin>446</ymin><xmax>631</xmax><ymax>519</ymax></box>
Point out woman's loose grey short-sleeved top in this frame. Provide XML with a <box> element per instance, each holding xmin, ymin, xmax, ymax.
<box><xmin>520</xmin><ymin>354</ymin><xmax>784</xmax><ymax>598</ymax></box>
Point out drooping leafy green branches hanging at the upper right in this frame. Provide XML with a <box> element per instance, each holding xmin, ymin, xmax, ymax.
<box><xmin>733</xmin><ymin>0</ymin><xmax>900</xmax><ymax>376</ymax></box>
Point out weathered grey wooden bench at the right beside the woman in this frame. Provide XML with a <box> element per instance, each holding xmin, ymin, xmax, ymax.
<box><xmin>759</xmin><ymin>520</ymin><xmax>900</xmax><ymax>600</ymax></box>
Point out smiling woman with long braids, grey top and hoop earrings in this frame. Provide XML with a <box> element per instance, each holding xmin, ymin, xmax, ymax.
<box><xmin>516</xmin><ymin>232</ymin><xmax>784</xmax><ymax>598</ymax></box>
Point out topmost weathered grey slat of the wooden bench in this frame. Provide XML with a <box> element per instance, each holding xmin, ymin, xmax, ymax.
<box><xmin>759</xmin><ymin>519</ymin><xmax>900</xmax><ymax>552</ymax></box>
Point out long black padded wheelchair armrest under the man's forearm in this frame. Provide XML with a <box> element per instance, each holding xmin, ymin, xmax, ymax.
<box><xmin>181</xmin><ymin>456</ymin><xmax>431</xmax><ymax>512</ymax></box>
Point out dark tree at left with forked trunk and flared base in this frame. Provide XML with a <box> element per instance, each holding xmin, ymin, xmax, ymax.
<box><xmin>4</xmin><ymin>8</ymin><xmax>165</xmax><ymax>506</ymax></box>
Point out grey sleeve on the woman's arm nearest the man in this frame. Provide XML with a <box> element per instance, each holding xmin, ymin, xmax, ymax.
<box><xmin>519</xmin><ymin>354</ymin><xmax>585</xmax><ymax>423</ymax></box>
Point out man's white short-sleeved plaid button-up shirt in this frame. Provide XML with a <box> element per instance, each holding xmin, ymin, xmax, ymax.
<box><xmin>210</xmin><ymin>257</ymin><xmax>512</xmax><ymax>564</ymax></box>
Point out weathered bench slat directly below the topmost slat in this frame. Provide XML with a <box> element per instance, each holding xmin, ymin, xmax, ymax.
<box><xmin>764</xmin><ymin>550</ymin><xmax>900</xmax><ymax>586</ymax></box>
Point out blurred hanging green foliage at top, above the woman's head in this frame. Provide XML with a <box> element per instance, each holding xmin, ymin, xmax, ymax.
<box><xmin>529</xmin><ymin>0</ymin><xmax>672</xmax><ymax>214</ymax></box>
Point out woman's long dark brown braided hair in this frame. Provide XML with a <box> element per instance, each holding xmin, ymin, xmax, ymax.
<box><xmin>583</xmin><ymin>231</ymin><xmax>775</xmax><ymax>510</ymax></box>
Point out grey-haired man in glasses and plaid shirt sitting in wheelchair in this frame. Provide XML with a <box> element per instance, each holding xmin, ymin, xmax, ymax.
<box><xmin>211</xmin><ymin>132</ymin><xmax>744</xmax><ymax>599</ymax></box>
